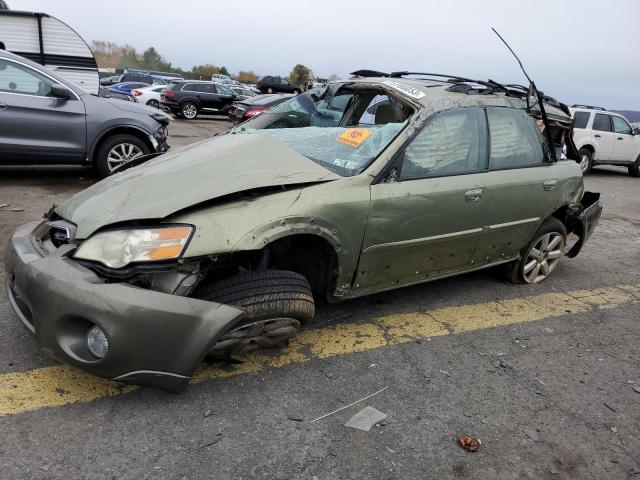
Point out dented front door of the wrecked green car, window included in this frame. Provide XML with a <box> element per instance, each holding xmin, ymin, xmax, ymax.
<box><xmin>356</xmin><ymin>108</ymin><xmax>489</xmax><ymax>293</ymax></box>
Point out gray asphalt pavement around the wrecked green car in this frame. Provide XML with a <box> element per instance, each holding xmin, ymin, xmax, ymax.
<box><xmin>0</xmin><ymin>118</ymin><xmax>640</xmax><ymax>479</ymax></box>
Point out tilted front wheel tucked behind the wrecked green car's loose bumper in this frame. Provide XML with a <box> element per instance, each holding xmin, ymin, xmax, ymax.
<box><xmin>195</xmin><ymin>270</ymin><xmax>315</xmax><ymax>358</ymax></box>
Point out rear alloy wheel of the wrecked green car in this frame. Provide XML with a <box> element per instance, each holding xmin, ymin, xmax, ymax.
<box><xmin>511</xmin><ymin>217</ymin><xmax>567</xmax><ymax>283</ymax></box>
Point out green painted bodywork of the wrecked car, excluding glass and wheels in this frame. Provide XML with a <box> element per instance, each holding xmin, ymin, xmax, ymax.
<box><xmin>6</xmin><ymin>78</ymin><xmax>601</xmax><ymax>390</ymax></box>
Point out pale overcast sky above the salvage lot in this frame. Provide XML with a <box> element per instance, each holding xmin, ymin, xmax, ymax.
<box><xmin>7</xmin><ymin>0</ymin><xmax>640</xmax><ymax>110</ymax></box>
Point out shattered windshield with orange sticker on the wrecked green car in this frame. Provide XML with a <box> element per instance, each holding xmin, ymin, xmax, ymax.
<box><xmin>231</xmin><ymin>84</ymin><xmax>413</xmax><ymax>176</ymax></box>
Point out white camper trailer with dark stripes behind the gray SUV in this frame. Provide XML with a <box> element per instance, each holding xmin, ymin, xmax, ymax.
<box><xmin>0</xmin><ymin>9</ymin><xmax>100</xmax><ymax>95</ymax></box>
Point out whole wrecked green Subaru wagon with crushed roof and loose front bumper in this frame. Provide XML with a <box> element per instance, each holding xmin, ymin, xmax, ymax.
<box><xmin>6</xmin><ymin>71</ymin><xmax>601</xmax><ymax>391</ymax></box>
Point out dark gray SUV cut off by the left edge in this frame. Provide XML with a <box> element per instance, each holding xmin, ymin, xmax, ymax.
<box><xmin>0</xmin><ymin>51</ymin><xmax>169</xmax><ymax>176</ymax></box>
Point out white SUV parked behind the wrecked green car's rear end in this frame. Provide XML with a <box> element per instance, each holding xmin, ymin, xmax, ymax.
<box><xmin>569</xmin><ymin>105</ymin><xmax>640</xmax><ymax>177</ymax></box>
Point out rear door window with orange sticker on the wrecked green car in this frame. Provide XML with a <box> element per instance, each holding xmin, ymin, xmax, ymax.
<box><xmin>487</xmin><ymin>108</ymin><xmax>544</xmax><ymax>170</ymax></box>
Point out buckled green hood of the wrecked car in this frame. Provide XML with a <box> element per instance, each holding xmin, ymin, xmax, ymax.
<box><xmin>55</xmin><ymin>134</ymin><xmax>341</xmax><ymax>239</ymax></box>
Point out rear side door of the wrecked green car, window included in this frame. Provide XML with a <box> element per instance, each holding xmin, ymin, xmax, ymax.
<box><xmin>477</xmin><ymin>107</ymin><xmax>565</xmax><ymax>264</ymax></box>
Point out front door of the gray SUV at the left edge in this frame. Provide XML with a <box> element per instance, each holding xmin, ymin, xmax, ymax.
<box><xmin>0</xmin><ymin>58</ymin><xmax>87</xmax><ymax>163</ymax></box>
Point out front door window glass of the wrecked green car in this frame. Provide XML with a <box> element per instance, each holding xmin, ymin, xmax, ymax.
<box><xmin>400</xmin><ymin>108</ymin><xmax>487</xmax><ymax>180</ymax></box>
